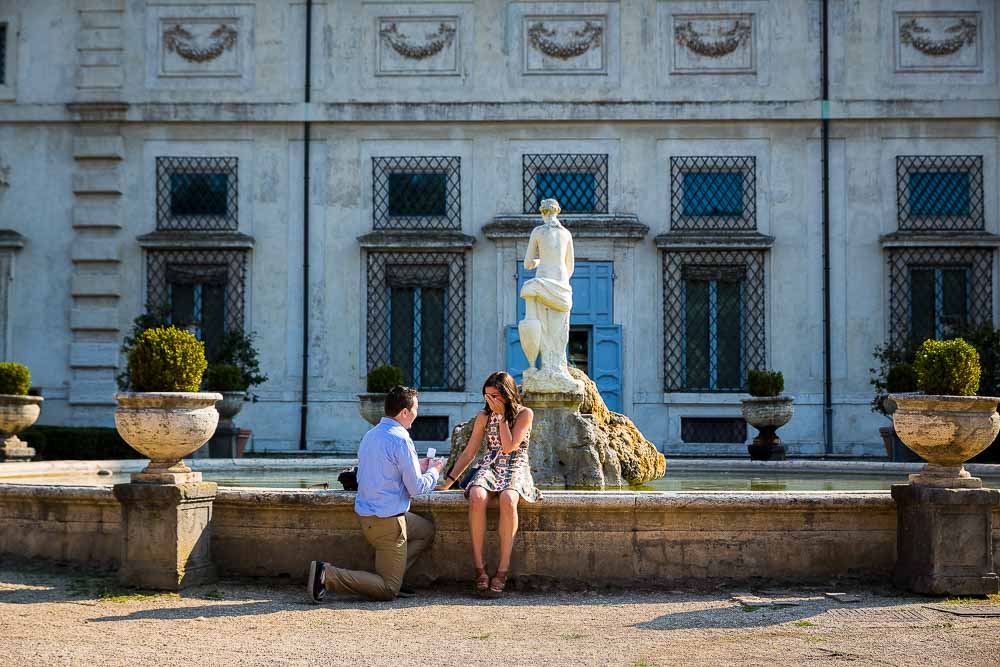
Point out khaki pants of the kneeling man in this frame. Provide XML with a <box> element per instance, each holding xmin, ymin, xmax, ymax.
<box><xmin>324</xmin><ymin>512</ymin><xmax>434</xmax><ymax>600</ymax></box>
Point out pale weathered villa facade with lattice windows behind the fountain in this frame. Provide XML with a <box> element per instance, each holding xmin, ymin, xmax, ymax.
<box><xmin>0</xmin><ymin>0</ymin><xmax>1000</xmax><ymax>456</ymax></box>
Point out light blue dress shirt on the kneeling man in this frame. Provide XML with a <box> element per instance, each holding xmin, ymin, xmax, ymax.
<box><xmin>354</xmin><ymin>417</ymin><xmax>438</xmax><ymax>518</ymax></box>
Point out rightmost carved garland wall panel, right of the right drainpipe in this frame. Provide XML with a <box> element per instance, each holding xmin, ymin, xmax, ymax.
<box><xmin>893</xmin><ymin>12</ymin><xmax>983</xmax><ymax>72</ymax></box>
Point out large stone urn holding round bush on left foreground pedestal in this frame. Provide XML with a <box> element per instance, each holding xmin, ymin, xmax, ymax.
<box><xmin>115</xmin><ymin>392</ymin><xmax>223</xmax><ymax>484</ymax></box>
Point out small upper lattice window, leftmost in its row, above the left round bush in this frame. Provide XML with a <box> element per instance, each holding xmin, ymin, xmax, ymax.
<box><xmin>156</xmin><ymin>157</ymin><xmax>239</xmax><ymax>232</ymax></box>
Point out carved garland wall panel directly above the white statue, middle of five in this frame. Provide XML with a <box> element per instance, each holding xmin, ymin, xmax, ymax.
<box><xmin>522</xmin><ymin>15</ymin><xmax>608</xmax><ymax>74</ymax></box>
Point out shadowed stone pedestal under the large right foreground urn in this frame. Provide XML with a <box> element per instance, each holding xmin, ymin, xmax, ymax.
<box><xmin>892</xmin><ymin>484</ymin><xmax>1000</xmax><ymax>595</ymax></box>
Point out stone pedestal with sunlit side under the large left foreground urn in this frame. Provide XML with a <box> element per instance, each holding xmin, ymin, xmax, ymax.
<box><xmin>114</xmin><ymin>482</ymin><xmax>218</xmax><ymax>591</ymax></box>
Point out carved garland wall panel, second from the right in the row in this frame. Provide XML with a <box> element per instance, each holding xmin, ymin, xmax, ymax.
<box><xmin>671</xmin><ymin>14</ymin><xmax>757</xmax><ymax>74</ymax></box>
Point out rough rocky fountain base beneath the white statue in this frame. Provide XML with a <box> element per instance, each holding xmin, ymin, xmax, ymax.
<box><xmin>449</xmin><ymin>368</ymin><xmax>666</xmax><ymax>489</ymax></box>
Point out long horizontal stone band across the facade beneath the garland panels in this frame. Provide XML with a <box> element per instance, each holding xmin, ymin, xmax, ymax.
<box><xmin>0</xmin><ymin>99</ymin><xmax>1000</xmax><ymax>123</ymax></box>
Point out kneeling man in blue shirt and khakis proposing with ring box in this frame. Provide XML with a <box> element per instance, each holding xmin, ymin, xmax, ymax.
<box><xmin>306</xmin><ymin>386</ymin><xmax>444</xmax><ymax>602</ymax></box>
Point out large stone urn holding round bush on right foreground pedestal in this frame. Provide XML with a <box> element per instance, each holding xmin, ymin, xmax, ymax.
<box><xmin>890</xmin><ymin>394</ymin><xmax>1000</xmax><ymax>489</ymax></box>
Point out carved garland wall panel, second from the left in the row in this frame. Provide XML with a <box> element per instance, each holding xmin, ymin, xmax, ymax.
<box><xmin>375</xmin><ymin>16</ymin><xmax>461</xmax><ymax>76</ymax></box>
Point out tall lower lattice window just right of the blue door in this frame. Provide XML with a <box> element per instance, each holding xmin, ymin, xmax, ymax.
<box><xmin>663</xmin><ymin>249</ymin><xmax>765</xmax><ymax>392</ymax></box>
